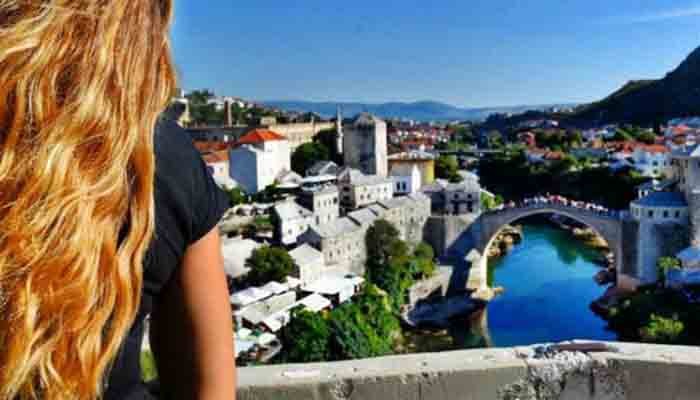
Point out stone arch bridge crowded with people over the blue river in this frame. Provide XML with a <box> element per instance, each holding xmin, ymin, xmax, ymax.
<box><xmin>467</xmin><ymin>203</ymin><xmax>624</xmax><ymax>290</ymax></box>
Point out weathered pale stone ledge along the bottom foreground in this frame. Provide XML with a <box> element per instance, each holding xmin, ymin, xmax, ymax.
<box><xmin>238</xmin><ymin>343</ymin><xmax>700</xmax><ymax>400</ymax></box>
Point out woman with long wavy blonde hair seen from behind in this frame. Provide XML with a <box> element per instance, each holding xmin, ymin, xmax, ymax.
<box><xmin>0</xmin><ymin>0</ymin><xmax>235</xmax><ymax>400</ymax></box>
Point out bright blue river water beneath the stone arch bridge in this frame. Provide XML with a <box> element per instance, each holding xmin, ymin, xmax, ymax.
<box><xmin>412</xmin><ymin>223</ymin><xmax>616</xmax><ymax>351</ymax></box>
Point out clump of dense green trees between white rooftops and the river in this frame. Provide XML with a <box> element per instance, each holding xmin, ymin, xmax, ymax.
<box><xmin>281</xmin><ymin>220</ymin><xmax>436</xmax><ymax>362</ymax></box>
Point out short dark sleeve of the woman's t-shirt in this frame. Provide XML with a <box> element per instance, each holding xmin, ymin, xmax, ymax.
<box><xmin>188</xmin><ymin>150</ymin><xmax>230</xmax><ymax>244</ymax></box>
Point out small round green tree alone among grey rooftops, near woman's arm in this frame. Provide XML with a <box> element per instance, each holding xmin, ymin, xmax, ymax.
<box><xmin>245</xmin><ymin>246</ymin><xmax>297</xmax><ymax>285</ymax></box>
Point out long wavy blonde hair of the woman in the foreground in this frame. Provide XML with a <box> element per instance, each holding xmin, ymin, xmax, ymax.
<box><xmin>0</xmin><ymin>0</ymin><xmax>175</xmax><ymax>399</ymax></box>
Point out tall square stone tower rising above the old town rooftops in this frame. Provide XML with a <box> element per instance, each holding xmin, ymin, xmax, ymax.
<box><xmin>342</xmin><ymin>113</ymin><xmax>389</xmax><ymax>177</ymax></box>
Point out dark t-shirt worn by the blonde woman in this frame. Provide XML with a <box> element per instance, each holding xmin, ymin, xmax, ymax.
<box><xmin>105</xmin><ymin>121</ymin><xmax>229</xmax><ymax>400</ymax></box>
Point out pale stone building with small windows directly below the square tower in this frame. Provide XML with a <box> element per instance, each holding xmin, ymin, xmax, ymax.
<box><xmin>338</xmin><ymin>168</ymin><xmax>394</xmax><ymax>210</ymax></box>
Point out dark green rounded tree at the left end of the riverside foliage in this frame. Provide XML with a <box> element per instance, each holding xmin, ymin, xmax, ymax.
<box><xmin>282</xmin><ymin>308</ymin><xmax>331</xmax><ymax>363</ymax></box>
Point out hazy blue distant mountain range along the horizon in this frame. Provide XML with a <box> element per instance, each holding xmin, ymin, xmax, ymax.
<box><xmin>262</xmin><ymin>100</ymin><xmax>574</xmax><ymax>121</ymax></box>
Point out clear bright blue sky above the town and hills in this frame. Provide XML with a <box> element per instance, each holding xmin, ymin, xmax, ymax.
<box><xmin>173</xmin><ymin>0</ymin><xmax>700</xmax><ymax>107</ymax></box>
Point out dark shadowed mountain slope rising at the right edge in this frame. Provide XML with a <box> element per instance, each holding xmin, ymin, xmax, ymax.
<box><xmin>569</xmin><ymin>47</ymin><xmax>700</xmax><ymax>126</ymax></box>
